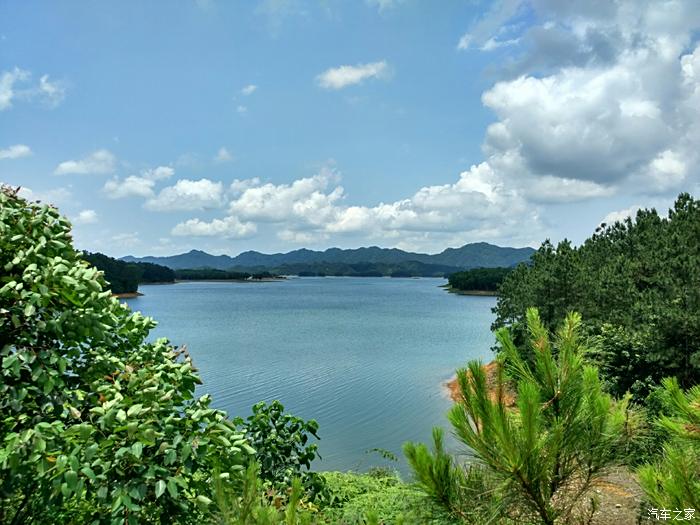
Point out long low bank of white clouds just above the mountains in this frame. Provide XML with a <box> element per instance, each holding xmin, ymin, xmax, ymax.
<box><xmin>173</xmin><ymin>167</ymin><xmax>538</xmax><ymax>249</ymax></box>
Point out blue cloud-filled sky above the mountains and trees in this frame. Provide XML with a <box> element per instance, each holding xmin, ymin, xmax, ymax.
<box><xmin>0</xmin><ymin>0</ymin><xmax>700</xmax><ymax>256</ymax></box>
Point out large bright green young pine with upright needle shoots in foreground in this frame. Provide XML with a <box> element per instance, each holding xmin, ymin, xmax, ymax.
<box><xmin>449</xmin><ymin>309</ymin><xmax>626</xmax><ymax>525</ymax></box>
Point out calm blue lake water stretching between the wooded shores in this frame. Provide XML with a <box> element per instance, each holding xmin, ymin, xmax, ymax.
<box><xmin>127</xmin><ymin>277</ymin><xmax>495</xmax><ymax>472</ymax></box>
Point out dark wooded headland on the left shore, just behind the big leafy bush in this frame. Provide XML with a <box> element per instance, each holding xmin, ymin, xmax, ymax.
<box><xmin>82</xmin><ymin>252</ymin><xmax>175</xmax><ymax>293</ymax></box>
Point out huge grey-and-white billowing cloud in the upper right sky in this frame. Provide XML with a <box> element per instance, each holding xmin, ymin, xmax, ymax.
<box><xmin>460</xmin><ymin>0</ymin><xmax>700</xmax><ymax>204</ymax></box>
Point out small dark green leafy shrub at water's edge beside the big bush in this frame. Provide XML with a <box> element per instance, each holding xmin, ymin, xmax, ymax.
<box><xmin>235</xmin><ymin>401</ymin><xmax>329</xmax><ymax>499</ymax></box>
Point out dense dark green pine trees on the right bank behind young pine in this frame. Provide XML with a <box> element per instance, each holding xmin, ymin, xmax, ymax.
<box><xmin>494</xmin><ymin>194</ymin><xmax>700</xmax><ymax>400</ymax></box>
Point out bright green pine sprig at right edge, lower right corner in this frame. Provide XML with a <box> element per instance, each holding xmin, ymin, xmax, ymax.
<box><xmin>639</xmin><ymin>378</ymin><xmax>700</xmax><ymax>509</ymax></box>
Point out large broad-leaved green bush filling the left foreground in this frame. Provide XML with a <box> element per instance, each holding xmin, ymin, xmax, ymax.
<box><xmin>0</xmin><ymin>188</ymin><xmax>254</xmax><ymax>525</ymax></box>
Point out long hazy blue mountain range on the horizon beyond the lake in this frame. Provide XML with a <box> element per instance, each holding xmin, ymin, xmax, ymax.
<box><xmin>122</xmin><ymin>242</ymin><xmax>535</xmax><ymax>271</ymax></box>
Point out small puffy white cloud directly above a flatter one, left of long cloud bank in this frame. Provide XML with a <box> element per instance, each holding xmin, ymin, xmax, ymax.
<box><xmin>145</xmin><ymin>179</ymin><xmax>225</xmax><ymax>211</ymax></box>
